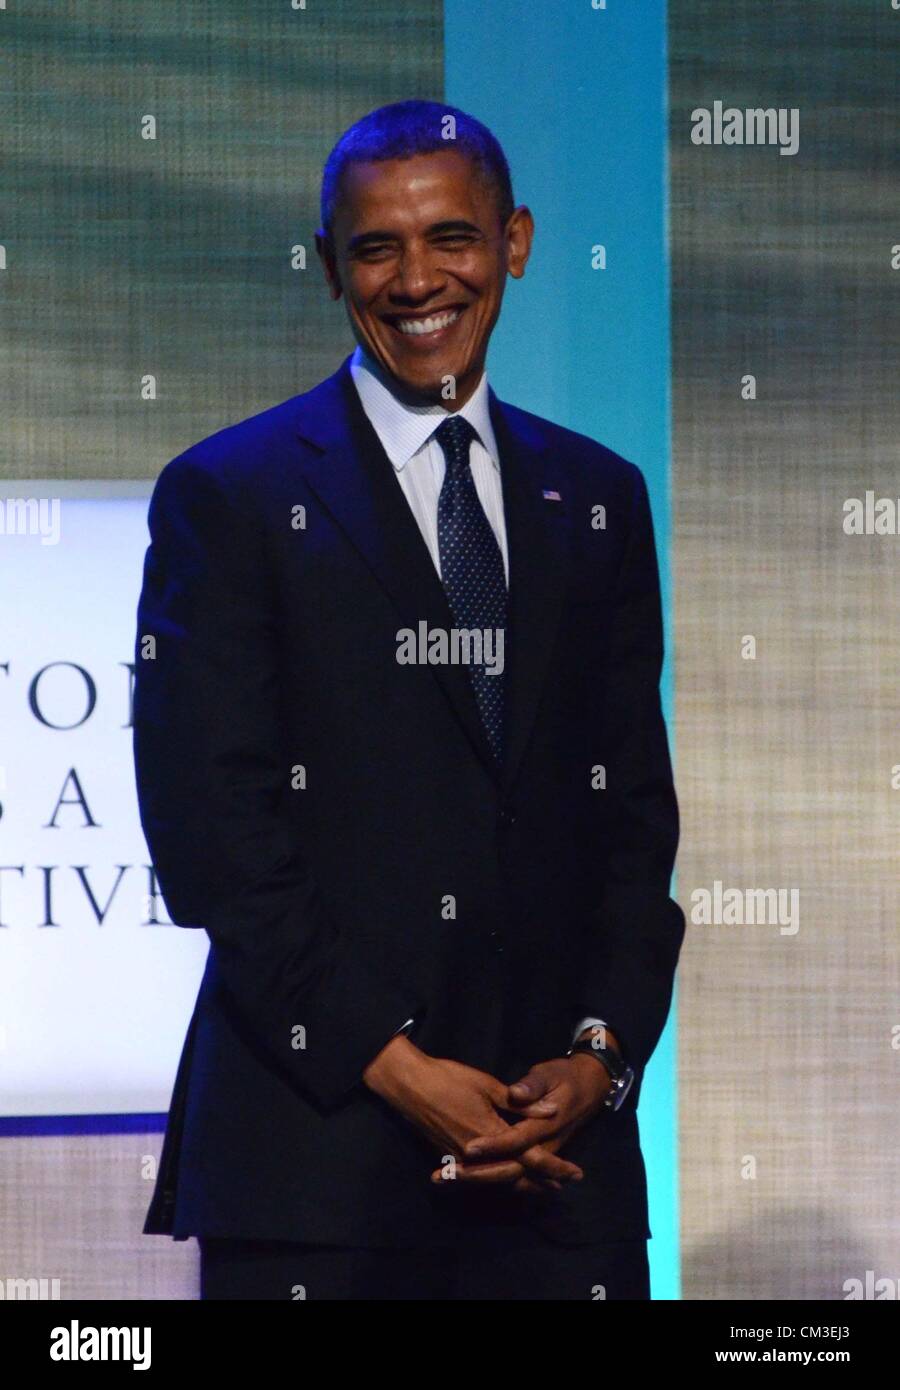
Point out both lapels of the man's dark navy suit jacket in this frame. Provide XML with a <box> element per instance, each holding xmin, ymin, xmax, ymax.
<box><xmin>296</xmin><ymin>357</ymin><xmax>568</xmax><ymax>791</ymax></box>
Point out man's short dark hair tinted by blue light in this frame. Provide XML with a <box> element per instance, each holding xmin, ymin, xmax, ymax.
<box><xmin>320</xmin><ymin>101</ymin><xmax>515</xmax><ymax>239</ymax></box>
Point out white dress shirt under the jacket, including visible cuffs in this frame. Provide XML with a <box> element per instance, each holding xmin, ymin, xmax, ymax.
<box><xmin>351</xmin><ymin>346</ymin><xmax>605</xmax><ymax>1040</ymax></box>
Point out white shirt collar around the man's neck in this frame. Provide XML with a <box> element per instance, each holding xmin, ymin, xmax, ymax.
<box><xmin>351</xmin><ymin>345</ymin><xmax>499</xmax><ymax>473</ymax></box>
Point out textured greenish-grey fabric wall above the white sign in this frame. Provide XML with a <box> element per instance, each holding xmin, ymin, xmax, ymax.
<box><xmin>0</xmin><ymin>0</ymin><xmax>442</xmax><ymax>478</ymax></box>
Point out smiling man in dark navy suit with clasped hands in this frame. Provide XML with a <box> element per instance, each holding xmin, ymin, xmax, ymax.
<box><xmin>135</xmin><ymin>101</ymin><xmax>684</xmax><ymax>1300</ymax></box>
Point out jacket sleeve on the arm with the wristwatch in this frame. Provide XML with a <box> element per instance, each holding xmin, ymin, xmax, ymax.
<box><xmin>581</xmin><ymin>467</ymin><xmax>684</xmax><ymax>1074</ymax></box>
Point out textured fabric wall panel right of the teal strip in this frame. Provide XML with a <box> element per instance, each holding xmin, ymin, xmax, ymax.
<box><xmin>669</xmin><ymin>0</ymin><xmax>900</xmax><ymax>1298</ymax></box>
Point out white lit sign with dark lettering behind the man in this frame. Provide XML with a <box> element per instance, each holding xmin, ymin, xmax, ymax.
<box><xmin>0</xmin><ymin>500</ymin><xmax>209</xmax><ymax>1116</ymax></box>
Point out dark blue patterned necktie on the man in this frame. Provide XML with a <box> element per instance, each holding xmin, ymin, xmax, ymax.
<box><xmin>434</xmin><ymin>414</ymin><xmax>508</xmax><ymax>763</ymax></box>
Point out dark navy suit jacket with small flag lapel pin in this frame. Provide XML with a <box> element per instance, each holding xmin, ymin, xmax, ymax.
<box><xmin>135</xmin><ymin>359</ymin><xmax>684</xmax><ymax>1247</ymax></box>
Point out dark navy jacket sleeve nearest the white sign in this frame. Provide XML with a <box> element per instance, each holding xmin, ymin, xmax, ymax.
<box><xmin>134</xmin><ymin>455</ymin><xmax>421</xmax><ymax>1109</ymax></box>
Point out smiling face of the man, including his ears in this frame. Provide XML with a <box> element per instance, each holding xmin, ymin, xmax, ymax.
<box><xmin>324</xmin><ymin>139</ymin><xmax>520</xmax><ymax>410</ymax></box>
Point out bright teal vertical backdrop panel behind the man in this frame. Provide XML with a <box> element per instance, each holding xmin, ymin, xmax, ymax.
<box><xmin>444</xmin><ymin>0</ymin><xmax>679</xmax><ymax>1298</ymax></box>
